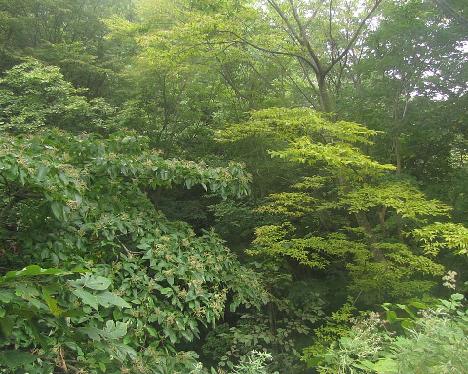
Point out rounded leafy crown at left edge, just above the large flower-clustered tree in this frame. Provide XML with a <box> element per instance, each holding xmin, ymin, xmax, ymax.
<box><xmin>0</xmin><ymin>60</ymin><xmax>113</xmax><ymax>133</ymax></box>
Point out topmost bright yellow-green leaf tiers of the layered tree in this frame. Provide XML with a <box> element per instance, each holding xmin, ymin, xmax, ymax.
<box><xmin>218</xmin><ymin>108</ymin><xmax>395</xmax><ymax>178</ymax></box>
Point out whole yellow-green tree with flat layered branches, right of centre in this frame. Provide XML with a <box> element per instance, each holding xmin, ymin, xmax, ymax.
<box><xmin>220</xmin><ymin>108</ymin><xmax>460</xmax><ymax>304</ymax></box>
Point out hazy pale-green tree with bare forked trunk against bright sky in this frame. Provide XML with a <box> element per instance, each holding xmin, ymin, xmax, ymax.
<box><xmin>192</xmin><ymin>0</ymin><xmax>381</xmax><ymax>112</ymax></box>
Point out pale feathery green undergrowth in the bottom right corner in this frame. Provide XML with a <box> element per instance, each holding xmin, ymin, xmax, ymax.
<box><xmin>314</xmin><ymin>294</ymin><xmax>467</xmax><ymax>374</ymax></box>
